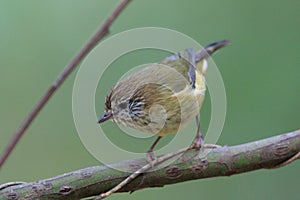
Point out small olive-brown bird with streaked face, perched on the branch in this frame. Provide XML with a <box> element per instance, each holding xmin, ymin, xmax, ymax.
<box><xmin>98</xmin><ymin>40</ymin><xmax>229</xmax><ymax>159</ymax></box>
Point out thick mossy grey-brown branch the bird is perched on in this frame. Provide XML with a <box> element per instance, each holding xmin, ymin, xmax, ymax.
<box><xmin>0</xmin><ymin>130</ymin><xmax>300</xmax><ymax>200</ymax></box>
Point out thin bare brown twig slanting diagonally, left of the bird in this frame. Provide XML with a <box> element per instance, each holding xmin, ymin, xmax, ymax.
<box><xmin>0</xmin><ymin>0</ymin><xmax>131</xmax><ymax>169</ymax></box>
